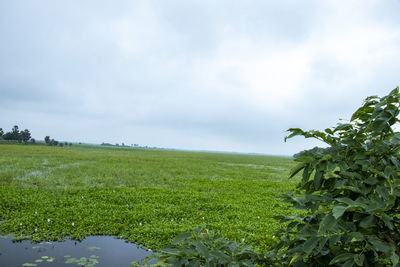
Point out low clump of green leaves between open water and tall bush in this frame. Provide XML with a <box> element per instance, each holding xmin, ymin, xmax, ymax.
<box><xmin>141</xmin><ymin>224</ymin><xmax>262</xmax><ymax>267</ymax></box>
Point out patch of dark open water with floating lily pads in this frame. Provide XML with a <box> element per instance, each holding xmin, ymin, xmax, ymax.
<box><xmin>0</xmin><ymin>236</ymin><xmax>151</xmax><ymax>267</ymax></box>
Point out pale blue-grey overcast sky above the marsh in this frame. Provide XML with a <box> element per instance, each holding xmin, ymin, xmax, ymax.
<box><xmin>0</xmin><ymin>0</ymin><xmax>400</xmax><ymax>155</ymax></box>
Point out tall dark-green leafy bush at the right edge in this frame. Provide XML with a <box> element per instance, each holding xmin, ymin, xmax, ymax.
<box><xmin>268</xmin><ymin>88</ymin><xmax>400</xmax><ymax>266</ymax></box>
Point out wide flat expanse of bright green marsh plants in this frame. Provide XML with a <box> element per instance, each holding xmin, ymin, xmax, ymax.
<box><xmin>0</xmin><ymin>145</ymin><xmax>296</xmax><ymax>249</ymax></box>
